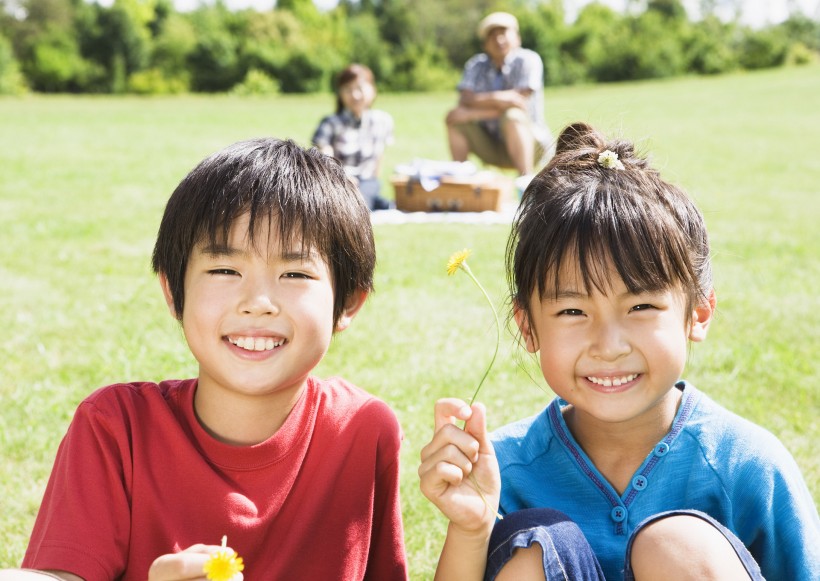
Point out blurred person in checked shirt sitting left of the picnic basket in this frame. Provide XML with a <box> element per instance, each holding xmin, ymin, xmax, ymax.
<box><xmin>312</xmin><ymin>64</ymin><xmax>393</xmax><ymax>210</ymax></box>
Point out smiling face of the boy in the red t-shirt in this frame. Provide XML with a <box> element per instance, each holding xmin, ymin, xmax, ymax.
<box><xmin>163</xmin><ymin>214</ymin><xmax>364</xmax><ymax>406</ymax></box>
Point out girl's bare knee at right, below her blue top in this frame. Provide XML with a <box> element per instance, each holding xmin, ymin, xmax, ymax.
<box><xmin>630</xmin><ymin>514</ymin><xmax>750</xmax><ymax>581</ymax></box>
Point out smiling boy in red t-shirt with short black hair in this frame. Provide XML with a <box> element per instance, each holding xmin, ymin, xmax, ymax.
<box><xmin>0</xmin><ymin>139</ymin><xmax>407</xmax><ymax>581</ymax></box>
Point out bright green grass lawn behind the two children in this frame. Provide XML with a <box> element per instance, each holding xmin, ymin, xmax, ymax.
<box><xmin>0</xmin><ymin>68</ymin><xmax>820</xmax><ymax>579</ymax></box>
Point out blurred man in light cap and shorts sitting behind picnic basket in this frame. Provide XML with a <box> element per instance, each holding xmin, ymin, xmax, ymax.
<box><xmin>446</xmin><ymin>12</ymin><xmax>551</xmax><ymax>175</ymax></box>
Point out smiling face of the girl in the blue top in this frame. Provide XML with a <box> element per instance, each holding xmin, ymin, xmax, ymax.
<box><xmin>516</xmin><ymin>264</ymin><xmax>713</xmax><ymax>426</ymax></box>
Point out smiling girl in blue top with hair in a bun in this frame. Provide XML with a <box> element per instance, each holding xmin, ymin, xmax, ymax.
<box><xmin>419</xmin><ymin>124</ymin><xmax>820</xmax><ymax>581</ymax></box>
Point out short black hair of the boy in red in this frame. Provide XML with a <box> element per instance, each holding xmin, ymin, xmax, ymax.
<box><xmin>153</xmin><ymin>138</ymin><xmax>376</xmax><ymax>326</ymax></box>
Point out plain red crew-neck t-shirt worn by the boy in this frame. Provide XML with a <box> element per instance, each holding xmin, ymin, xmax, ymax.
<box><xmin>23</xmin><ymin>378</ymin><xmax>407</xmax><ymax>581</ymax></box>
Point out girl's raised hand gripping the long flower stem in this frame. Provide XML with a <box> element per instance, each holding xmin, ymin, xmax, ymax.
<box><xmin>419</xmin><ymin>398</ymin><xmax>501</xmax><ymax>535</ymax></box>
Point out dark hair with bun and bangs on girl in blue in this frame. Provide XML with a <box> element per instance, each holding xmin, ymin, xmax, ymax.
<box><xmin>506</xmin><ymin>123</ymin><xmax>712</xmax><ymax>326</ymax></box>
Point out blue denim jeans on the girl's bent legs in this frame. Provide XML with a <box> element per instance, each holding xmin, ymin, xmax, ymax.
<box><xmin>484</xmin><ymin>508</ymin><xmax>764</xmax><ymax>581</ymax></box>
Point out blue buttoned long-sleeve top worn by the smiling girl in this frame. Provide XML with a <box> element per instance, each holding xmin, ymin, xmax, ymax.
<box><xmin>492</xmin><ymin>382</ymin><xmax>820</xmax><ymax>581</ymax></box>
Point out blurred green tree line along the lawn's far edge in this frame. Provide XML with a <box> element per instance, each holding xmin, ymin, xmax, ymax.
<box><xmin>0</xmin><ymin>0</ymin><xmax>820</xmax><ymax>94</ymax></box>
